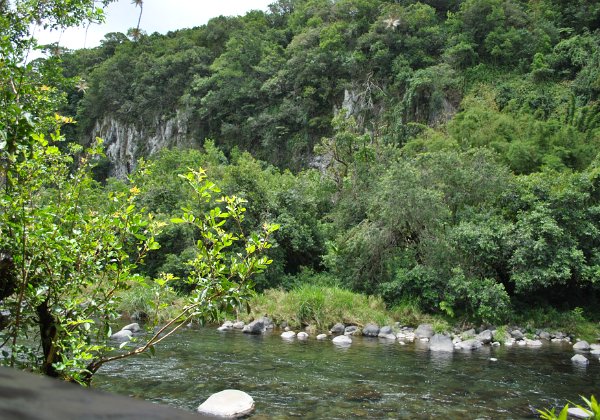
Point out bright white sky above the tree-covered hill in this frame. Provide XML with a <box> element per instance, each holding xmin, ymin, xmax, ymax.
<box><xmin>36</xmin><ymin>0</ymin><xmax>274</xmax><ymax>49</ymax></box>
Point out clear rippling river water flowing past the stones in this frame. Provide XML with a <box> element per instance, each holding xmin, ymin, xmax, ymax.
<box><xmin>94</xmin><ymin>328</ymin><xmax>600</xmax><ymax>419</ymax></box>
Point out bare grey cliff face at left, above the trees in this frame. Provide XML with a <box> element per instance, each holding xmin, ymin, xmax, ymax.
<box><xmin>90</xmin><ymin>111</ymin><xmax>194</xmax><ymax>178</ymax></box>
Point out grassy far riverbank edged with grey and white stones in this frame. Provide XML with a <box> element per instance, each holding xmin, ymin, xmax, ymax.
<box><xmin>120</xmin><ymin>284</ymin><xmax>600</xmax><ymax>342</ymax></box>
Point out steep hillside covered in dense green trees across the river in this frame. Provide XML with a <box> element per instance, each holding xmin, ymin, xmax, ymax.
<box><xmin>61</xmin><ymin>0</ymin><xmax>600</xmax><ymax>321</ymax></box>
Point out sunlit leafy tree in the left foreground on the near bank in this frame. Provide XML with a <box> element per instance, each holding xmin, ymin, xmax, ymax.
<box><xmin>0</xmin><ymin>0</ymin><xmax>277</xmax><ymax>384</ymax></box>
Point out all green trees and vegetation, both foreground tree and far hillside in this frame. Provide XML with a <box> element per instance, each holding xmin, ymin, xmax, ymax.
<box><xmin>0</xmin><ymin>0</ymin><xmax>600</xmax><ymax>382</ymax></box>
